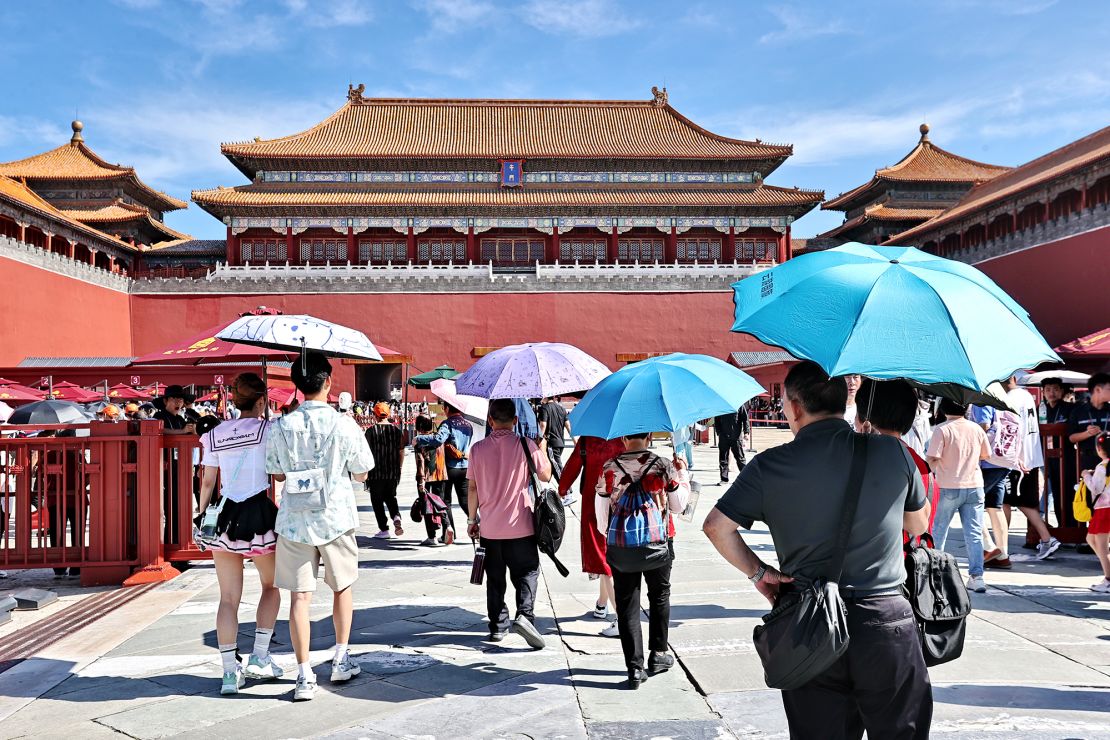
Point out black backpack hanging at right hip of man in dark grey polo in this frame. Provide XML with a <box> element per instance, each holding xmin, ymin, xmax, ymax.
<box><xmin>904</xmin><ymin>535</ymin><xmax>971</xmax><ymax>666</ymax></box>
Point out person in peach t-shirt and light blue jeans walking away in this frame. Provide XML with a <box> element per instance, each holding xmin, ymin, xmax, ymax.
<box><xmin>926</xmin><ymin>398</ymin><xmax>994</xmax><ymax>594</ymax></box>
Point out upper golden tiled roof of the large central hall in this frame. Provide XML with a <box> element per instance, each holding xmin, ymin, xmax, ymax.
<box><xmin>221</xmin><ymin>90</ymin><xmax>793</xmax><ymax>163</ymax></box>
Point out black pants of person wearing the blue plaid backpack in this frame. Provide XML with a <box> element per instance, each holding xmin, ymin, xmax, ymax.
<box><xmin>613</xmin><ymin>554</ymin><xmax>670</xmax><ymax>672</ymax></box>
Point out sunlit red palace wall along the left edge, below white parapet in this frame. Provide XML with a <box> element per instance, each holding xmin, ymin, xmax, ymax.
<box><xmin>0</xmin><ymin>257</ymin><xmax>132</xmax><ymax>366</ymax></box>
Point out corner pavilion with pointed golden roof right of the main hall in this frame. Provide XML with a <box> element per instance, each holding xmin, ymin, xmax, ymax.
<box><xmin>818</xmin><ymin>123</ymin><xmax>1009</xmax><ymax>244</ymax></box>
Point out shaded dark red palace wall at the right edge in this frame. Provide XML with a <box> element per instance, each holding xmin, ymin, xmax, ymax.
<box><xmin>976</xmin><ymin>227</ymin><xmax>1110</xmax><ymax>346</ymax></box>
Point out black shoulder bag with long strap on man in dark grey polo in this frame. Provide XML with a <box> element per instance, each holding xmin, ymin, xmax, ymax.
<box><xmin>753</xmin><ymin>434</ymin><xmax>868</xmax><ymax>691</ymax></box>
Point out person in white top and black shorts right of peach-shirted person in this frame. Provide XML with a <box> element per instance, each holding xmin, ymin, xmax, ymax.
<box><xmin>1002</xmin><ymin>376</ymin><xmax>1060</xmax><ymax>560</ymax></box>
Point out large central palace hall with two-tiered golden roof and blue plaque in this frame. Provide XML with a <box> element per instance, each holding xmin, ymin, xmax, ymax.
<box><xmin>193</xmin><ymin>85</ymin><xmax>821</xmax><ymax>270</ymax></box>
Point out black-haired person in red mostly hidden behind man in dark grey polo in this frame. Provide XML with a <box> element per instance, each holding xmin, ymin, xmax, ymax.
<box><xmin>856</xmin><ymin>378</ymin><xmax>940</xmax><ymax>540</ymax></box>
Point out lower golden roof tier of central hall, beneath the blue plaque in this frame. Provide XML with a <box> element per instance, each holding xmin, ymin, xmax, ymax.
<box><xmin>193</xmin><ymin>184</ymin><xmax>824</xmax><ymax>207</ymax></box>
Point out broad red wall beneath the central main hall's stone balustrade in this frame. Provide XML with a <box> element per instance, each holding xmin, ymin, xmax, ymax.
<box><xmin>131</xmin><ymin>292</ymin><xmax>781</xmax><ymax>389</ymax></box>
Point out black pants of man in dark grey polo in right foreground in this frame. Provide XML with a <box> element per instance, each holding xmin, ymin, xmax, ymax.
<box><xmin>783</xmin><ymin>596</ymin><xmax>932</xmax><ymax>740</ymax></box>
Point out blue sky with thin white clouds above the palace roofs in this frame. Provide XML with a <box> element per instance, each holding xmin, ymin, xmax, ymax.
<box><xmin>0</xmin><ymin>0</ymin><xmax>1110</xmax><ymax>237</ymax></box>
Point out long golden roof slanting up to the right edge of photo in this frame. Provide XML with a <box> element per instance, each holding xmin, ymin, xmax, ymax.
<box><xmin>889</xmin><ymin>126</ymin><xmax>1110</xmax><ymax>242</ymax></box>
